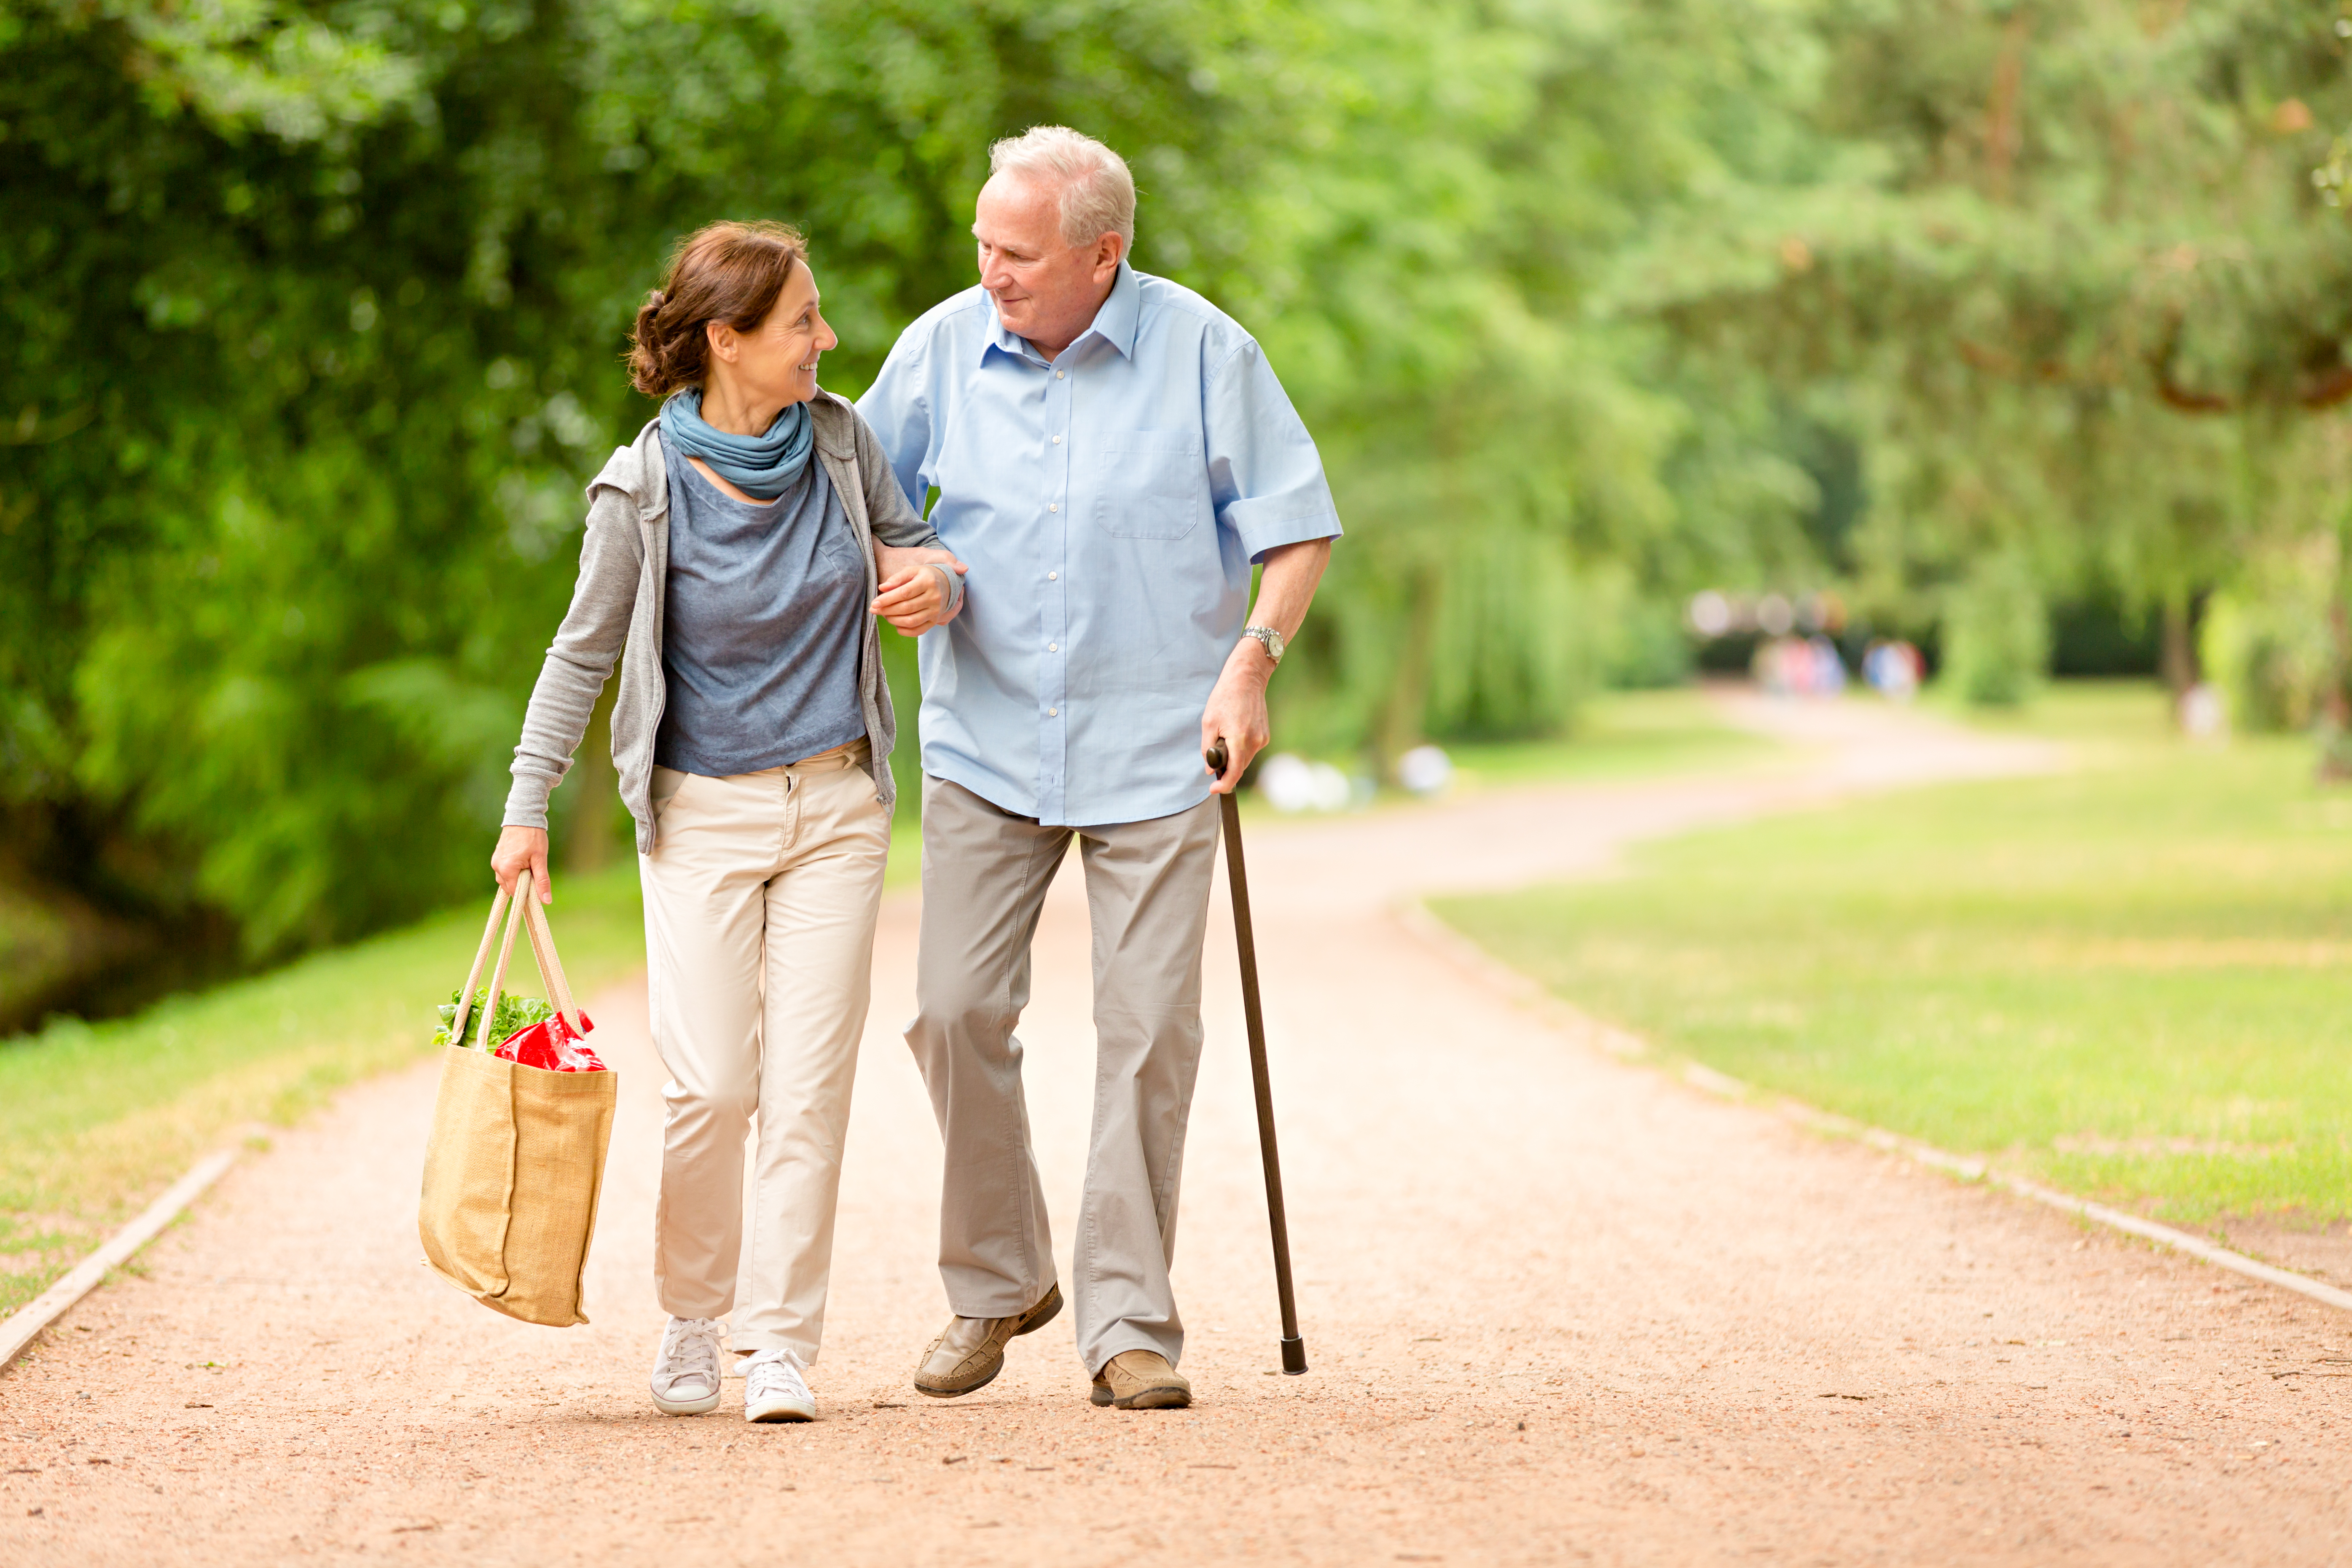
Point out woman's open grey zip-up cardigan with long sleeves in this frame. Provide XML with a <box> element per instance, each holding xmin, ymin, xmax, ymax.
<box><xmin>506</xmin><ymin>390</ymin><xmax>962</xmax><ymax>854</ymax></box>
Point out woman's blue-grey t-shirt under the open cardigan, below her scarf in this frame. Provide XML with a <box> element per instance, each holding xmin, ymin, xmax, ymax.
<box><xmin>654</xmin><ymin>437</ymin><xmax>865</xmax><ymax>778</ymax></box>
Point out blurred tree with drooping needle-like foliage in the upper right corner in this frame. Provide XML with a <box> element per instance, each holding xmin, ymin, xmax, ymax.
<box><xmin>1644</xmin><ymin>0</ymin><xmax>2352</xmax><ymax>710</ymax></box>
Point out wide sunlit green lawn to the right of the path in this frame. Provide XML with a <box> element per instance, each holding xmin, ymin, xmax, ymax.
<box><xmin>1439</xmin><ymin>684</ymin><xmax>2352</xmax><ymax>1222</ymax></box>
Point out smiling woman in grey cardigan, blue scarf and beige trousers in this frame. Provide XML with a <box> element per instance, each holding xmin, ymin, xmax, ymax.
<box><xmin>491</xmin><ymin>223</ymin><xmax>962</xmax><ymax>1420</ymax></box>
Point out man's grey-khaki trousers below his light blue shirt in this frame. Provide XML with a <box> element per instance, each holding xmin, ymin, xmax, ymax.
<box><xmin>905</xmin><ymin>778</ymin><xmax>1216</xmax><ymax>1373</ymax></box>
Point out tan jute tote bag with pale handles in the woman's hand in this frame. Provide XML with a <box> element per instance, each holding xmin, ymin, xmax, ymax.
<box><xmin>416</xmin><ymin>872</ymin><xmax>621</xmax><ymax>1328</ymax></box>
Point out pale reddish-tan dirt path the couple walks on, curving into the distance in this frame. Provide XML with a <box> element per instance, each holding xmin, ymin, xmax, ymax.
<box><xmin>0</xmin><ymin>703</ymin><xmax>2352</xmax><ymax>1568</ymax></box>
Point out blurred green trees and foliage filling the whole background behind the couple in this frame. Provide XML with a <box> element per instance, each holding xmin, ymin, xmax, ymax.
<box><xmin>0</xmin><ymin>0</ymin><xmax>2352</xmax><ymax>1027</ymax></box>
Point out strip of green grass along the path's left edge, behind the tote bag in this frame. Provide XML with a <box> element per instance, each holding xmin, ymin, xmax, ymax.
<box><xmin>0</xmin><ymin>863</ymin><xmax>644</xmax><ymax>1314</ymax></box>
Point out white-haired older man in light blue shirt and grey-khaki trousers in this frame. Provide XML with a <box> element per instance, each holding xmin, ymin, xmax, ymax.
<box><xmin>859</xmin><ymin>125</ymin><xmax>1341</xmax><ymax>1410</ymax></box>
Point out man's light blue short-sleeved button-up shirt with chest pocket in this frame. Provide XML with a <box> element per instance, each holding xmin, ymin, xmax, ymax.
<box><xmin>859</xmin><ymin>263</ymin><xmax>1341</xmax><ymax>827</ymax></box>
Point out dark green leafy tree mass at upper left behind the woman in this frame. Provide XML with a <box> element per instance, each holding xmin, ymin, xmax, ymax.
<box><xmin>0</xmin><ymin>0</ymin><xmax>1275</xmax><ymax>983</ymax></box>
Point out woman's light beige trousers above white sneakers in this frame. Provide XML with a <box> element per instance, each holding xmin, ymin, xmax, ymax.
<box><xmin>637</xmin><ymin>741</ymin><xmax>889</xmax><ymax>1364</ymax></box>
